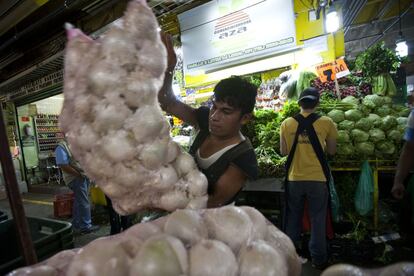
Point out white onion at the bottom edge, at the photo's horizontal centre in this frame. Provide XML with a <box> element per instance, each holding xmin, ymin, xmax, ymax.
<box><xmin>189</xmin><ymin>240</ymin><xmax>238</xmax><ymax>276</ymax></box>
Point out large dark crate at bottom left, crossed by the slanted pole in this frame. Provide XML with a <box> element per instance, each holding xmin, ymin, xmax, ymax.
<box><xmin>0</xmin><ymin>217</ymin><xmax>74</xmax><ymax>275</ymax></box>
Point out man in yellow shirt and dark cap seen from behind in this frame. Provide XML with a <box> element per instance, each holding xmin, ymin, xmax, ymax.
<box><xmin>280</xmin><ymin>88</ymin><xmax>338</xmax><ymax>268</ymax></box>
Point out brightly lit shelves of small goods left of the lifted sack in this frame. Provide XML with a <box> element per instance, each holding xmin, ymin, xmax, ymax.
<box><xmin>35</xmin><ymin>114</ymin><xmax>63</xmax><ymax>153</ymax></box>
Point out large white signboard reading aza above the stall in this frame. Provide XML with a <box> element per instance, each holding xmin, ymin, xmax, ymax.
<box><xmin>178</xmin><ymin>0</ymin><xmax>296</xmax><ymax>75</ymax></box>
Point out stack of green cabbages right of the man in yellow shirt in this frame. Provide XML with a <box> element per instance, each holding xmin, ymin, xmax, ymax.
<box><xmin>327</xmin><ymin>95</ymin><xmax>409</xmax><ymax>159</ymax></box>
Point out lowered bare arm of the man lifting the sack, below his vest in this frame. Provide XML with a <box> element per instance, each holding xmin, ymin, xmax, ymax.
<box><xmin>207</xmin><ymin>165</ymin><xmax>247</xmax><ymax>208</ymax></box>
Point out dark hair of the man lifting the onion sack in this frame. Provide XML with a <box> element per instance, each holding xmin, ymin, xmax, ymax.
<box><xmin>214</xmin><ymin>76</ymin><xmax>257</xmax><ymax>115</ymax></box>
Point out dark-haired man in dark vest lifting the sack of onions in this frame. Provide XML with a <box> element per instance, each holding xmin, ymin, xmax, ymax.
<box><xmin>158</xmin><ymin>34</ymin><xmax>258</xmax><ymax>208</ymax></box>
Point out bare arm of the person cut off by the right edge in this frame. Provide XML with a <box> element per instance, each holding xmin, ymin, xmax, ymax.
<box><xmin>391</xmin><ymin>141</ymin><xmax>414</xmax><ymax>199</ymax></box>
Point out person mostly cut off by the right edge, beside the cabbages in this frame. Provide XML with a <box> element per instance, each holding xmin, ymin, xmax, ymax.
<box><xmin>391</xmin><ymin>106</ymin><xmax>414</xmax><ymax>248</ymax></box>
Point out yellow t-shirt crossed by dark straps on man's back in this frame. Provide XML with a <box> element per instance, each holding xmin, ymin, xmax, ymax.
<box><xmin>280</xmin><ymin>113</ymin><xmax>338</xmax><ymax>181</ymax></box>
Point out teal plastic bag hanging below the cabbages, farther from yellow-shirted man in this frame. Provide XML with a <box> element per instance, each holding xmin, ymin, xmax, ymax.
<box><xmin>354</xmin><ymin>161</ymin><xmax>374</xmax><ymax>216</ymax></box>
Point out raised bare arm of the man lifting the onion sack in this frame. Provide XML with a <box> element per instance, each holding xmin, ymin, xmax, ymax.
<box><xmin>158</xmin><ymin>33</ymin><xmax>197</xmax><ymax>126</ymax></box>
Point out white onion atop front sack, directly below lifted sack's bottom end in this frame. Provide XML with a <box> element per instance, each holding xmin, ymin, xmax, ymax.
<box><xmin>164</xmin><ymin>210</ymin><xmax>208</xmax><ymax>245</ymax></box>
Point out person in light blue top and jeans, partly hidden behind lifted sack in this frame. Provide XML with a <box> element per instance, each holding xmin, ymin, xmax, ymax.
<box><xmin>55</xmin><ymin>140</ymin><xmax>99</xmax><ymax>234</ymax></box>
